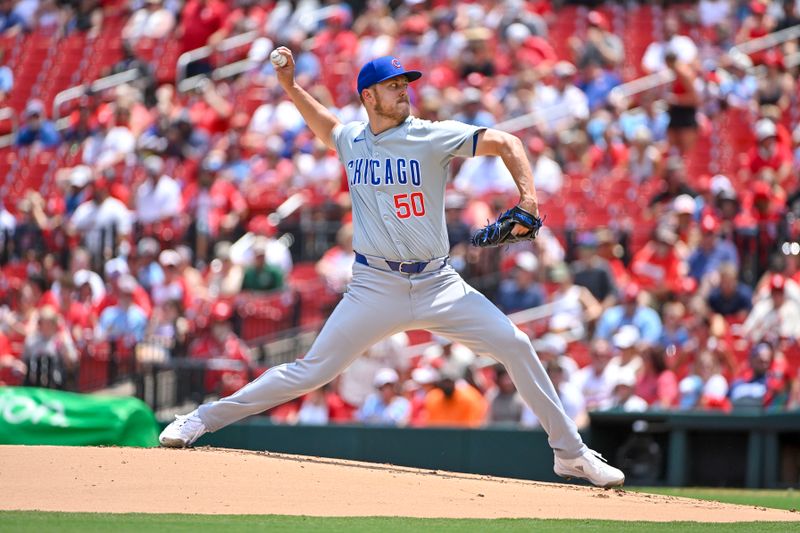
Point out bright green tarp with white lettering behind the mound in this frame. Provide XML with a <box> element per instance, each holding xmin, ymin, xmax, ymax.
<box><xmin>0</xmin><ymin>387</ymin><xmax>158</xmax><ymax>447</ymax></box>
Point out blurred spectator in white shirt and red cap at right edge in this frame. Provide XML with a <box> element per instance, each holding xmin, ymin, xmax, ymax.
<box><xmin>742</xmin><ymin>274</ymin><xmax>800</xmax><ymax>342</ymax></box>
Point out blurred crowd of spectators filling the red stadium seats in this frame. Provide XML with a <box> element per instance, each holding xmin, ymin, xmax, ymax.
<box><xmin>0</xmin><ymin>0</ymin><xmax>800</xmax><ymax>427</ymax></box>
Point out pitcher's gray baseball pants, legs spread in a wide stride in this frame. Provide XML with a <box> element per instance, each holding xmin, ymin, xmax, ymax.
<box><xmin>198</xmin><ymin>263</ymin><xmax>586</xmax><ymax>459</ymax></box>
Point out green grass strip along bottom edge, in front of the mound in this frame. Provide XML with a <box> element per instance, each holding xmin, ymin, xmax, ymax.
<box><xmin>0</xmin><ymin>511</ymin><xmax>800</xmax><ymax>533</ymax></box>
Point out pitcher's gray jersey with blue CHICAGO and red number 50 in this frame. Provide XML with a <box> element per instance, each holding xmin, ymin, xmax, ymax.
<box><xmin>333</xmin><ymin>116</ymin><xmax>485</xmax><ymax>261</ymax></box>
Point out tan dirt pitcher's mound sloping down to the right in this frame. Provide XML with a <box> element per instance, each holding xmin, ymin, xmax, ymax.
<box><xmin>0</xmin><ymin>446</ymin><xmax>800</xmax><ymax>522</ymax></box>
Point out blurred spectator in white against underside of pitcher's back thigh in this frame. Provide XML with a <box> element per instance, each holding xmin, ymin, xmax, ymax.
<box><xmin>339</xmin><ymin>332</ymin><xmax>409</xmax><ymax>407</ymax></box>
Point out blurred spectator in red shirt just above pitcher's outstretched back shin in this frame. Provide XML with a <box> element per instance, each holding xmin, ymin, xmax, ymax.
<box><xmin>189</xmin><ymin>301</ymin><xmax>250</xmax><ymax>396</ymax></box>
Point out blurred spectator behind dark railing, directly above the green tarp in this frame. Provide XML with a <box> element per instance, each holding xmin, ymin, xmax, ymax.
<box><xmin>22</xmin><ymin>305</ymin><xmax>78</xmax><ymax>389</ymax></box>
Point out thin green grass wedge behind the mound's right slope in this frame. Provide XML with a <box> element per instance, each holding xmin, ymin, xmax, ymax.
<box><xmin>625</xmin><ymin>487</ymin><xmax>800</xmax><ymax>511</ymax></box>
